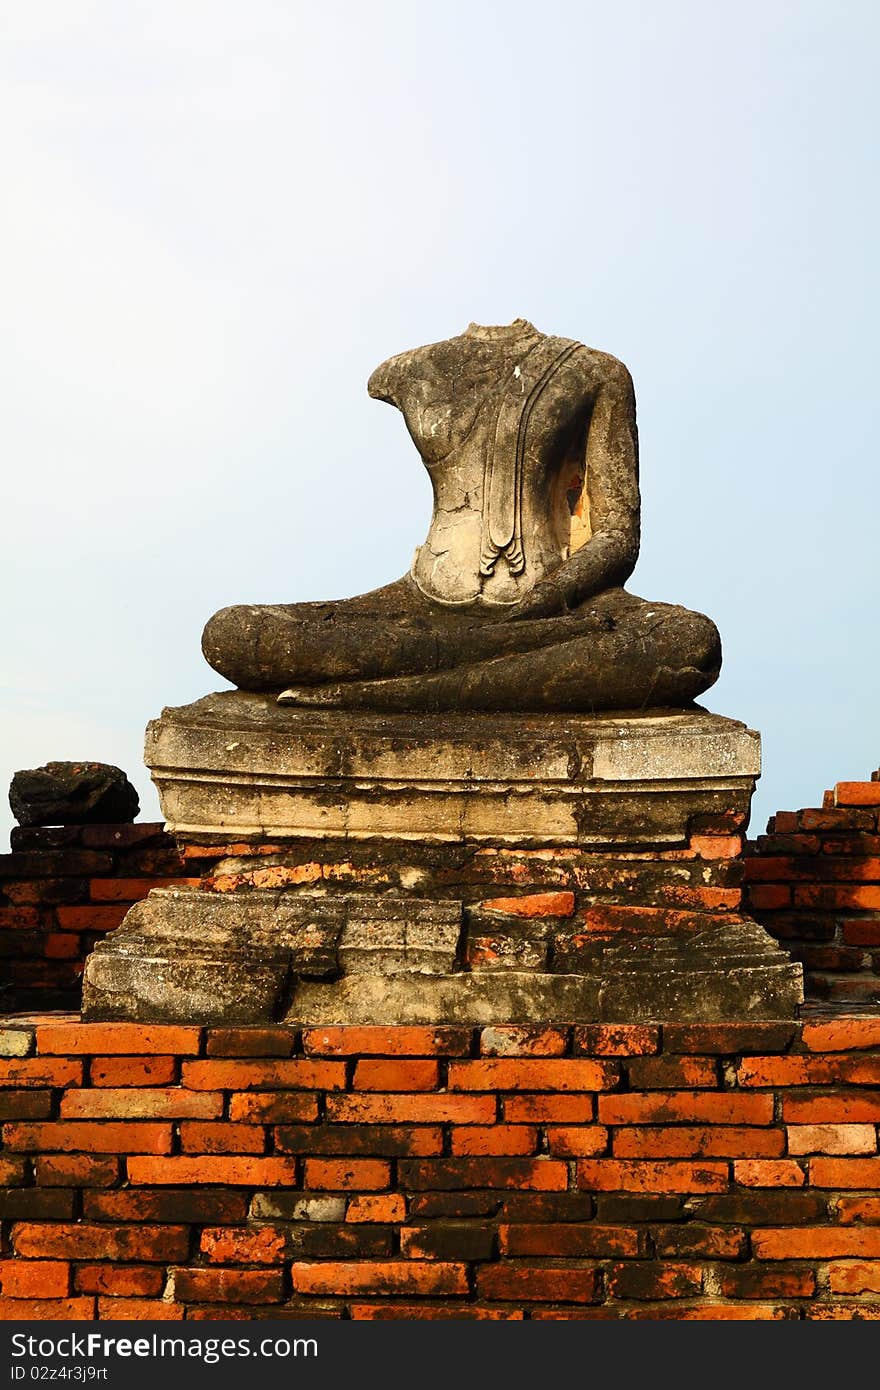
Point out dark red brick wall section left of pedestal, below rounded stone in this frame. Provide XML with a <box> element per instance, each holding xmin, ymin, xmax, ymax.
<box><xmin>0</xmin><ymin>823</ymin><xmax>196</xmax><ymax>1009</ymax></box>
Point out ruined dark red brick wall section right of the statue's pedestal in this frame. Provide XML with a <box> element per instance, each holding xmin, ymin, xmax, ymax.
<box><xmin>745</xmin><ymin>773</ymin><xmax>880</xmax><ymax>1002</ymax></box>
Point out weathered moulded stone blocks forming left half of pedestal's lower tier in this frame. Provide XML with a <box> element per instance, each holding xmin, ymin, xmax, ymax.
<box><xmin>82</xmin><ymin>888</ymin><xmax>462</xmax><ymax>1023</ymax></box>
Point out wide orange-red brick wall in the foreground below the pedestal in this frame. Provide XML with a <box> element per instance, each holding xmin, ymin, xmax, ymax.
<box><xmin>0</xmin><ymin>1016</ymin><xmax>880</xmax><ymax>1321</ymax></box>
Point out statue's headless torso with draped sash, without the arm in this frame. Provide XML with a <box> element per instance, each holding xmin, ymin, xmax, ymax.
<box><xmin>368</xmin><ymin>320</ymin><xmax>589</xmax><ymax>605</ymax></box>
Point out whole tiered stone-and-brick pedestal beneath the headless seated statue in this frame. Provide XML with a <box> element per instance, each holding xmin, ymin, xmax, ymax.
<box><xmin>83</xmin><ymin>692</ymin><xmax>802</xmax><ymax>1024</ymax></box>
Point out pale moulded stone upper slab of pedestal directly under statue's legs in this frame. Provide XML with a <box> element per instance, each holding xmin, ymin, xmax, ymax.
<box><xmin>145</xmin><ymin>691</ymin><xmax>760</xmax><ymax>848</ymax></box>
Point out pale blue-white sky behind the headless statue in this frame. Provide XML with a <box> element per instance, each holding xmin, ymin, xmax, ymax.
<box><xmin>0</xmin><ymin>0</ymin><xmax>880</xmax><ymax>841</ymax></box>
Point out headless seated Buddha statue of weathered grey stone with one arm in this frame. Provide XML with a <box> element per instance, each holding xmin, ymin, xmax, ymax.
<box><xmin>203</xmin><ymin>318</ymin><xmax>722</xmax><ymax>712</ymax></box>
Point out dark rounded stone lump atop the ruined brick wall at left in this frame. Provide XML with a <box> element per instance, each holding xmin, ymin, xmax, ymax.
<box><xmin>10</xmin><ymin>763</ymin><xmax>139</xmax><ymax>826</ymax></box>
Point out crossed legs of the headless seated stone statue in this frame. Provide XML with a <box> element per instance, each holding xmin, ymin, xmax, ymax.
<box><xmin>203</xmin><ymin>578</ymin><xmax>722</xmax><ymax>712</ymax></box>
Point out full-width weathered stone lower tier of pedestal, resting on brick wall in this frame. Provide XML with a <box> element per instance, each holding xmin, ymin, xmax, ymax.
<box><xmin>83</xmin><ymin>890</ymin><xmax>801</xmax><ymax>1024</ymax></box>
